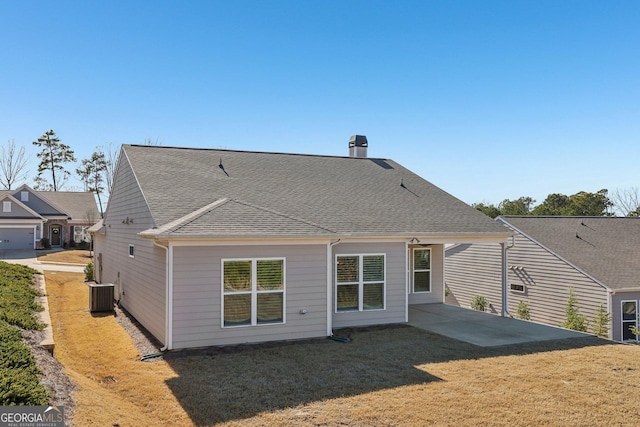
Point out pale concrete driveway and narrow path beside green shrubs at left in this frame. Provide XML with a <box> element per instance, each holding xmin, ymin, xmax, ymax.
<box><xmin>0</xmin><ymin>249</ymin><xmax>84</xmax><ymax>353</ymax></box>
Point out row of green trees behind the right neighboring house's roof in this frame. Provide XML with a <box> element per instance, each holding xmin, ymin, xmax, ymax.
<box><xmin>471</xmin><ymin>188</ymin><xmax>640</xmax><ymax>218</ymax></box>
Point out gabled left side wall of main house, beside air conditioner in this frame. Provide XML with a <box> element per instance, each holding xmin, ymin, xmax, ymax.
<box><xmin>101</xmin><ymin>156</ymin><xmax>166</xmax><ymax>343</ymax></box>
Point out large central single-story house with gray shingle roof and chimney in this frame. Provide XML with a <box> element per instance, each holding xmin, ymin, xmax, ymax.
<box><xmin>94</xmin><ymin>140</ymin><xmax>511</xmax><ymax>349</ymax></box>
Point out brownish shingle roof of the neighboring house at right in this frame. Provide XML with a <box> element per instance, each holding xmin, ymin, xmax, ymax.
<box><xmin>498</xmin><ymin>216</ymin><xmax>640</xmax><ymax>289</ymax></box>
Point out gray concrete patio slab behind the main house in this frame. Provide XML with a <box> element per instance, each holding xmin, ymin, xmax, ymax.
<box><xmin>409</xmin><ymin>304</ymin><xmax>590</xmax><ymax>347</ymax></box>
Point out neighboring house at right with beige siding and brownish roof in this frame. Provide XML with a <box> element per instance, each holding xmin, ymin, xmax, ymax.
<box><xmin>445</xmin><ymin>216</ymin><xmax>640</xmax><ymax>341</ymax></box>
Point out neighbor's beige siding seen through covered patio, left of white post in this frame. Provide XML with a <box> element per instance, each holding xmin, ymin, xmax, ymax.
<box><xmin>445</xmin><ymin>243</ymin><xmax>502</xmax><ymax>314</ymax></box>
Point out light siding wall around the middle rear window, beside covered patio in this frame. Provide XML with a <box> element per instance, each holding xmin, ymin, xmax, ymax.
<box><xmin>331</xmin><ymin>242</ymin><xmax>406</xmax><ymax>329</ymax></box>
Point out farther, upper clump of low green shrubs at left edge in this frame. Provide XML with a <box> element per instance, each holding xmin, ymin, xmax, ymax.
<box><xmin>0</xmin><ymin>261</ymin><xmax>45</xmax><ymax>329</ymax></box>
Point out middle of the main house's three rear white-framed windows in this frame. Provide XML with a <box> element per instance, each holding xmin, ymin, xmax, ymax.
<box><xmin>336</xmin><ymin>254</ymin><xmax>386</xmax><ymax>311</ymax></box>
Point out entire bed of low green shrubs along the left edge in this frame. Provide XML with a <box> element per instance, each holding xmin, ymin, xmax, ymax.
<box><xmin>0</xmin><ymin>261</ymin><xmax>49</xmax><ymax>406</ymax></box>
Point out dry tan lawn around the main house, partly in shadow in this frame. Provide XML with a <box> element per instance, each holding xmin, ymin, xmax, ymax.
<box><xmin>45</xmin><ymin>273</ymin><xmax>640</xmax><ymax>427</ymax></box>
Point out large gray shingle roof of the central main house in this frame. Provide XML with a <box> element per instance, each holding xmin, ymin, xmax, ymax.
<box><xmin>123</xmin><ymin>145</ymin><xmax>506</xmax><ymax>236</ymax></box>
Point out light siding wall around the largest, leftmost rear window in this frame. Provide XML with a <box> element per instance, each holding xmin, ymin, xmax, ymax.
<box><xmin>173</xmin><ymin>244</ymin><xmax>327</xmax><ymax>349</ymax></box>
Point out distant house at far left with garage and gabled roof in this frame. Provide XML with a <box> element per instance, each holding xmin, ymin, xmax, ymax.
<box><xmin>0</xmin><ymin>185</ymin><xmax>100</xmax><ymax>250</ymax></box>
